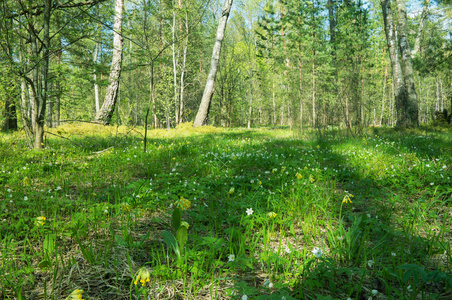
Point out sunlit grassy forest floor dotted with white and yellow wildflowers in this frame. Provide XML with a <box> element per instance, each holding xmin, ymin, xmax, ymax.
<box><xmin>0</xmin><ymin>124</ymin><xmax>452</xmax><ymax>300</ymax></box>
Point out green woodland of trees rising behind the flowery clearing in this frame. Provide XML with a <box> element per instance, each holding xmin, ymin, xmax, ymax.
<box><xmin>0</xmin><ymin>0</ymin><xmax>452</xmax><ymax>141</ymax></box>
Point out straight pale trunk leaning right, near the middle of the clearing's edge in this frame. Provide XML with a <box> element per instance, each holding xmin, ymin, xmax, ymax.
<box><xmin>193</xmin><ymin>0</ymin><xmax>233</xmax><ymax>127</ymax></box>
